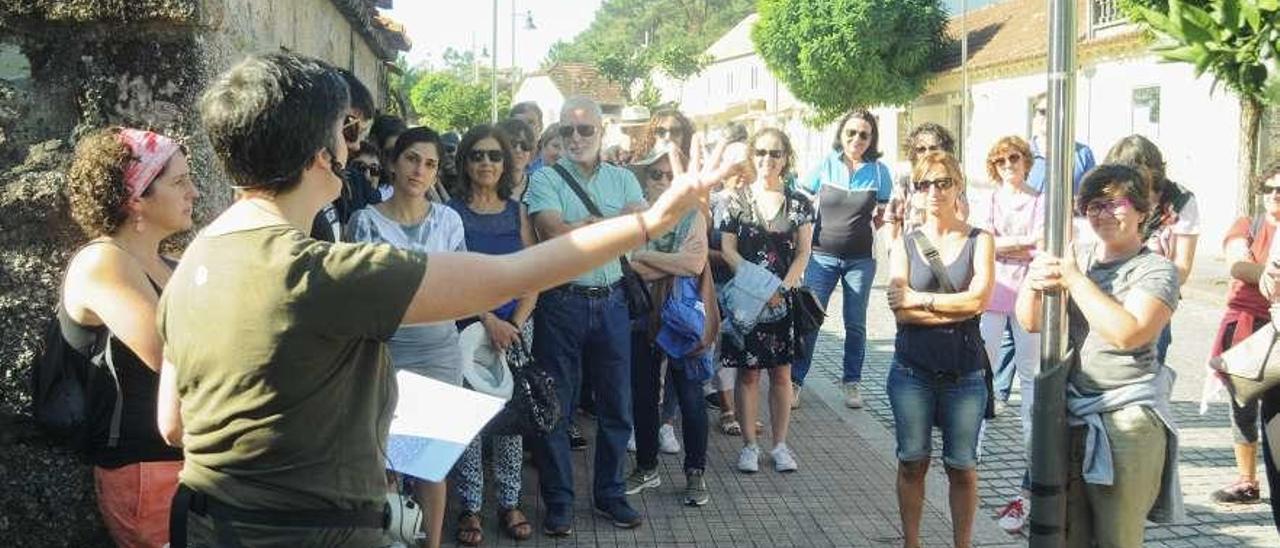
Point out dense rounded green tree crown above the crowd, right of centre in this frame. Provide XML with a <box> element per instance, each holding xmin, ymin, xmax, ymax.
<box><xmin>751</xmin><ymin>0</ymin><xmax>947</xmax><ymax>123</ymax></box>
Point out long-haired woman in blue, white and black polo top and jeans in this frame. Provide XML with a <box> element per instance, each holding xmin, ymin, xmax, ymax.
<box><xmin>795</xmin><ymin>110</ymin><xmax>893</xmax><ymax>408</ymax></box>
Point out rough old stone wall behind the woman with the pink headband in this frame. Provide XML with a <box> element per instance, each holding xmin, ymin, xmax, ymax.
<box><xmin>0</xmin><ymin>0</ymin><xmax>385</xmax><ymax>547</ymax></box>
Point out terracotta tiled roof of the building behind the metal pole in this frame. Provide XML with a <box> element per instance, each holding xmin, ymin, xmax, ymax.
<box><xmin>937</xmin><ymin>0</ymin><xmax>1139</xmax><ymax>73</ymax></box>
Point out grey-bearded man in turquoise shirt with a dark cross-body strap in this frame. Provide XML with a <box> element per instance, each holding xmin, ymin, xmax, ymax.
<box><xmin>525</xmin><ymin>97</ymin><xmax>646</xmax><ymax>536</ymax></box>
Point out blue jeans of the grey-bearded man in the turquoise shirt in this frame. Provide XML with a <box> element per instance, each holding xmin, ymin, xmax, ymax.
<box><xmin>532</xmin><ymin>288</ymin><xmax>631</xmax><ymax>515</ymax></box>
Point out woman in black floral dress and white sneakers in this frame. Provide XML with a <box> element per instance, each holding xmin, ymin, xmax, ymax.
<box><xmin>719</xmin><ymin>128</ymin><xmax>814</xmax><ymax>472</ymax></box>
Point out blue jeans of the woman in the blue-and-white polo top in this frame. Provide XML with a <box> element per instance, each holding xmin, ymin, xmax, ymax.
<box><xmin>791</xmin><ymin>251</ymin><xmax>876</xmax><ymax>385</ymax></box>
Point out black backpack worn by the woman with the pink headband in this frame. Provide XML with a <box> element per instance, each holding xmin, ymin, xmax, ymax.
<box><xmin>31</xmin><ymin>290</ymin><xmax>124</xmax><ymax>458</ymax></box>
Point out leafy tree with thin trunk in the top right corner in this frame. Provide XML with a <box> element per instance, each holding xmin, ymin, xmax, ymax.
<box><xmin>1120</xmin><ymin>0</ymin><xmax>1280</xmax><ymax>202</ymax></box>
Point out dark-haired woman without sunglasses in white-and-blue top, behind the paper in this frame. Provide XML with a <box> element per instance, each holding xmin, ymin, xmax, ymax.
<box><xmin>344</xmin><ymin>127</ymin><xmax>466</xmax><ymax>545</ymax></box>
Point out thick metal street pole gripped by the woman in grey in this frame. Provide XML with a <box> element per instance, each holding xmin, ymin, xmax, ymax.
<box><xmin>1028</xmin><ymin>0</ymin><xmax>1075</xmax><ymax>548</ymax></box>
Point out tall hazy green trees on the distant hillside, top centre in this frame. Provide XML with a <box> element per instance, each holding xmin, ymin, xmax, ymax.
<box><xmin>543</xmin><ymin>0</ymin><xmax>755</xmax><ymax>99</ymax></box>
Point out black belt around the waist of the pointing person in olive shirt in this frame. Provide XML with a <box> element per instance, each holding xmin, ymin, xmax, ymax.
<box><xmin>169</xmin><ymin>484</ymin><xmax>390</xmax><ymax>548</ymax></box>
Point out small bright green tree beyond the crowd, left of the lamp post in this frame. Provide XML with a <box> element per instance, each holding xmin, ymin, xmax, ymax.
<box><xmin>410</xmin><ymin>70</ymin><xmax>511</xmax><ymax>132</ymax></box>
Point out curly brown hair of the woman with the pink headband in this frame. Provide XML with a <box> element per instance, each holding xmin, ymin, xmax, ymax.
<box><xmin>67</xmin><ymin>127</ymin><xmax>151</xmax><ymax>238</ymax></box>
